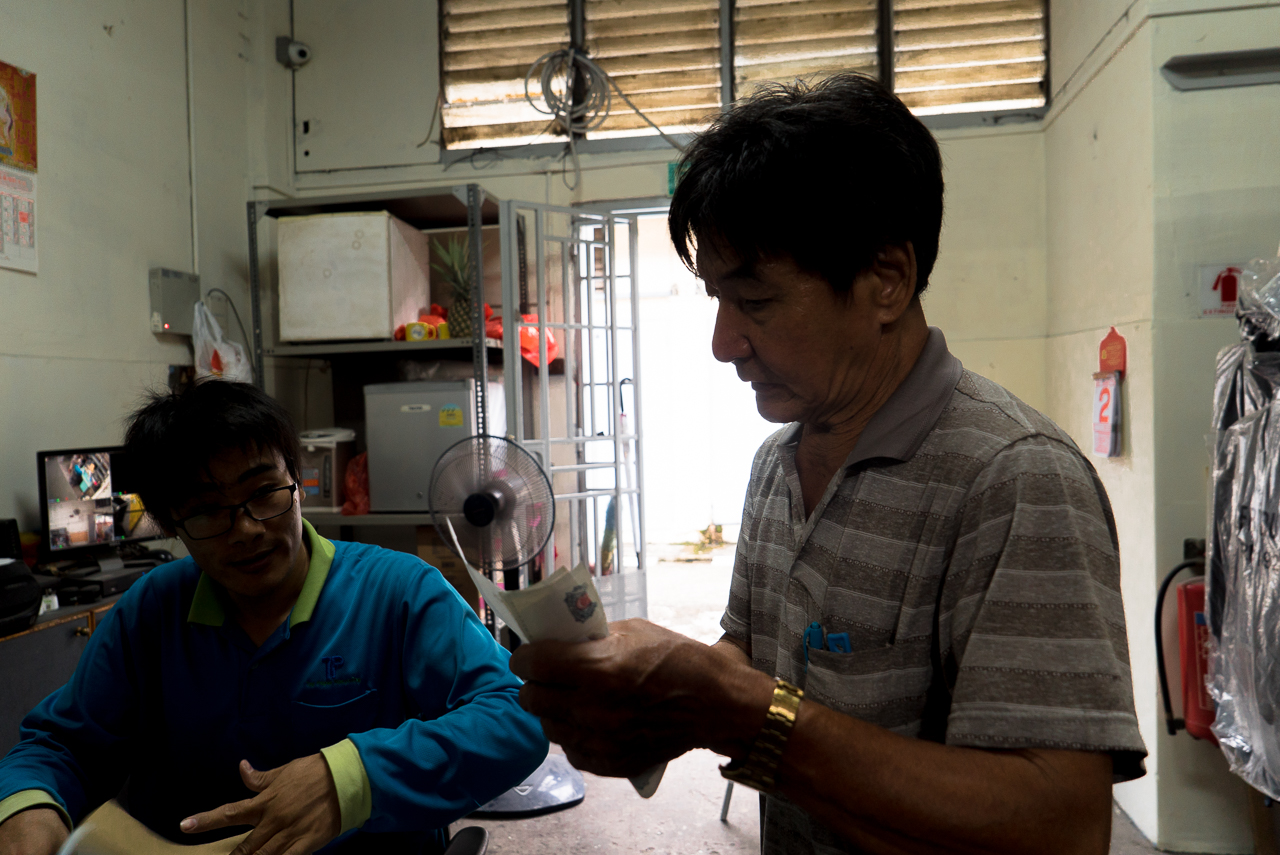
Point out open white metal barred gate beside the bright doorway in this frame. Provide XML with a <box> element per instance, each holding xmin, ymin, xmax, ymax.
<box><xmin>499</xmin><ymin>201</ymin><xmax>648</xmax><ymax>621</ymax></box>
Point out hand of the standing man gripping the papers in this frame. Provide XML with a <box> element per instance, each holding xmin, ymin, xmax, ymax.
<box><xmin>511</xmin><ymin>619</ymin><xmax>773</xmax><ymax>777</ymax></box>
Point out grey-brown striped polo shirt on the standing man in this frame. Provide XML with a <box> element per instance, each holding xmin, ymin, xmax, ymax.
<box><xmin>721</xmin><ymin>328</ymin><xmax>1147</xmax><ymax>855</ymax></box>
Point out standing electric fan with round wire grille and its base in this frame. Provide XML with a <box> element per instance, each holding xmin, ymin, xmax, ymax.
<box><xmin>429</xmin><ymin>436</ymin><xmax>586</xmax><ymax>818</ymax></box>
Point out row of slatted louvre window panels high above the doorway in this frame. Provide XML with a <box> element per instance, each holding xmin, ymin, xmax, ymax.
<box><xmin>440</xmin><ymin>0</ymin><xmax>1046</xmax><ymax>148</ymax></box>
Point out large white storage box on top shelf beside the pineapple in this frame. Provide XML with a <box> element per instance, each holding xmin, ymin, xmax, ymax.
<box><xmin>278</xmin><ymin>211</ymin><xmax>431</xmax><ymax>342</ymax></box>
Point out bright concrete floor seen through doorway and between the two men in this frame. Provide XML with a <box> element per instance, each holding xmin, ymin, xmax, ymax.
<box><xmin>454</xmin><ymin>545</ymin><xmax>1172</xmax><ymax>855</ymax></box>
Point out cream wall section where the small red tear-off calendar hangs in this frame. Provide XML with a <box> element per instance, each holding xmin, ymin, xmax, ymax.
<box><xmin>1044</xmin><ymin>21</ymin><xmax>1158</xmax><ymax>837</ymax></box>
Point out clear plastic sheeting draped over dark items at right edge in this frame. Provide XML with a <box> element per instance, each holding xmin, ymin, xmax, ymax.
<box><xmin>1206</xmin><ymin>253</ymin><xmax>1280</xmax><ymax>799</ymax></box>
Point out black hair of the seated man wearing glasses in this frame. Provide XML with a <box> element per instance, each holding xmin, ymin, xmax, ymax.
<box><xmin>124</xmin><ymin>380</ymin><xmax>302</xmax><ymax>532</ymax></box>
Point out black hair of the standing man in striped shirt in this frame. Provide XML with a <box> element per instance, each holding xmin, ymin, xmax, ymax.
<box><xmin>668</xmin><ymin>73</ymin><xmax>942</xmax><ymax>296</ymax></box>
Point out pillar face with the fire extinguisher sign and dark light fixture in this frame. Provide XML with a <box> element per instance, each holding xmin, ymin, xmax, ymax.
<box><xmin>1148</xmin><ymin>6</ymin><xmax>1280</xmax><ymax>851</ymax></box>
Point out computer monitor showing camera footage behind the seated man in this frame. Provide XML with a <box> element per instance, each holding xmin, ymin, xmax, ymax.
<box><xmin>36</xmin><ymin>445</ymin><xmax>166</xmax><ymax>566</ymax></box>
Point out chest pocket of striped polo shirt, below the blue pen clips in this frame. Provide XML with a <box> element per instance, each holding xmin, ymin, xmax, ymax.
<box><xmin>804</xmin><ymin>640</ymin><xmax>933</xmax><ymax>736</ymax></box>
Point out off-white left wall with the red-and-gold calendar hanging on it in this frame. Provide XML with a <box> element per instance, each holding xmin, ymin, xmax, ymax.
<box><xmin>0</xmin><ymin>0</ymin><xmax>248</xmax><ymax>529</ymax></box>
